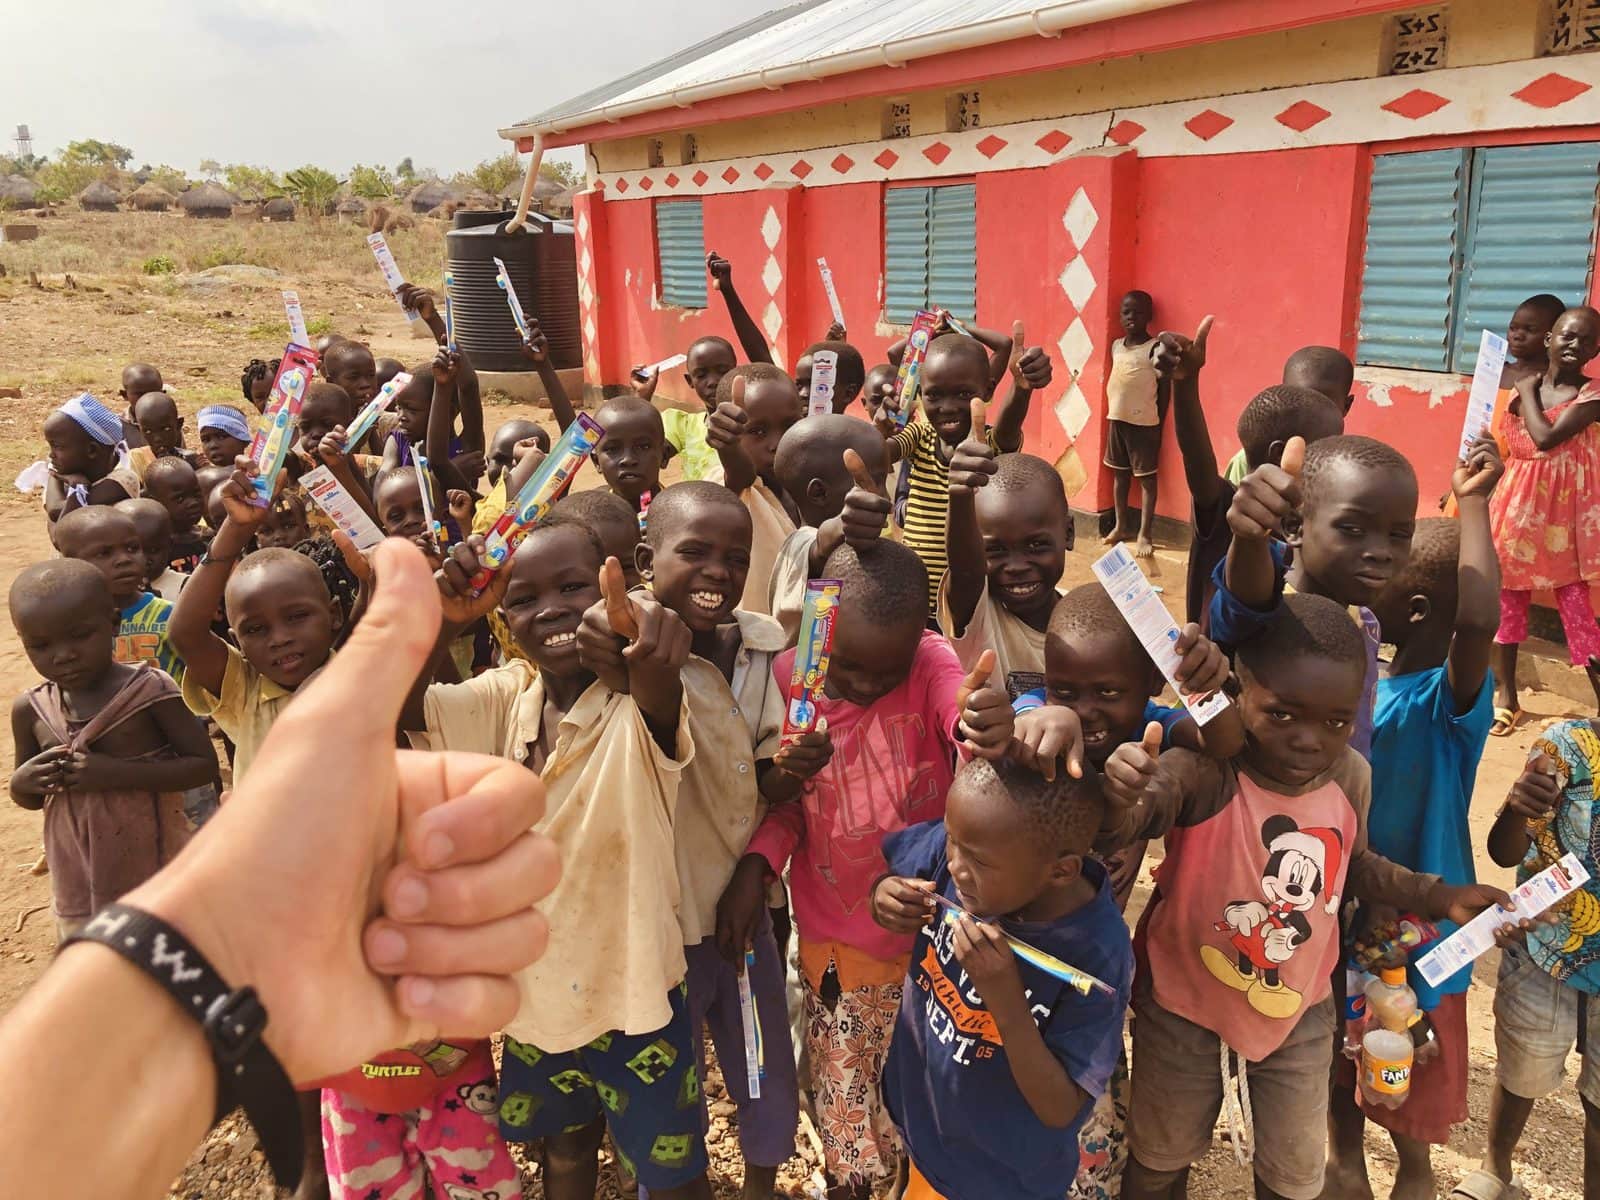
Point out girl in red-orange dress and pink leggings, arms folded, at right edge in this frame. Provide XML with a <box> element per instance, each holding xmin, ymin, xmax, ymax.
<box><xmin>1490</xmin><ymin>307</ymin><xmax>1600</xmax><ymax>738</ymax></box>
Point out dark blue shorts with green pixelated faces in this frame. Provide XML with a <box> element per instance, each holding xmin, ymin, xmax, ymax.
<box><xmin>499</xmin><ymin>984</ymin><xmax>707</xmax><ymax>1190</ymax></box>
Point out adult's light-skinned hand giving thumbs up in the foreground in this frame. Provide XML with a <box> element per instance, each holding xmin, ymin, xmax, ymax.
<box><xmin>125</xmin><ymin>541</ymin><xmax>560</xmax><ymax>1083</ymax></box>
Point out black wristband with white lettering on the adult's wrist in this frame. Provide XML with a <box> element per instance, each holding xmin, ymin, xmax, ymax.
<box><xmin>62</xmin><ymin>904</ymin><xmax>306</xmax><ymax>1190</ymax></box>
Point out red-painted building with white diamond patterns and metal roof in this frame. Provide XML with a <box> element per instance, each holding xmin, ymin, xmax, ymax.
<box><xmin>502</xmin><ymin>0</ymin><xmax>1600</xmax><ymax>528</ymax></box>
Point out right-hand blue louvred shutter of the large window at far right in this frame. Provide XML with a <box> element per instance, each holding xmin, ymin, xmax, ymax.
<box><xmin>1454</xmin><ymin>142</ymin><xmax>1600</xmax><ymax>371</ymax></box>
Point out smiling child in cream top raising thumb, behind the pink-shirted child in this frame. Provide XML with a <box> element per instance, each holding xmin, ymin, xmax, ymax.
<box><xmin>938</xmin><ymin>403</ymin><xmax>1072</xmax><ymax>699</ymax></box>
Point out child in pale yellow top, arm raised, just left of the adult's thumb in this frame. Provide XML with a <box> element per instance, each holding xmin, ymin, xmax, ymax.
<box><xmin>170</xmin><ymin>474</ymin><xmax>342</xmax><ymax>784</ymax></box>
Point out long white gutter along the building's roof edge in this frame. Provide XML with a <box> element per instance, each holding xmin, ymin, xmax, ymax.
<box><xmin>499</xmin><ymin>0</ymin><xmax>1189</xmax><ymax>142</ymax></box>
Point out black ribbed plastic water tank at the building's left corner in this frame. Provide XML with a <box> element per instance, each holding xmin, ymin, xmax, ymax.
<box><xmin>445</xmin><ymin>211</ymin><xmax>584</xmax><ymax>371</ymax></box>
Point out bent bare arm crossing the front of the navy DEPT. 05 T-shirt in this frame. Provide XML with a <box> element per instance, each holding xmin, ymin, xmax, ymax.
<box><xmin>950</xmin><ymin>914</ymin><xmax>1090</xmax><ymax>1130</ymax></box>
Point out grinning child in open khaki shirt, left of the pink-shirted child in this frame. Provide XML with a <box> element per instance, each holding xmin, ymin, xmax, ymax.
<box><xmin>638</xmin><ymin>480</ymin><xmax>829</xmax><ymax>1200</ymax></box>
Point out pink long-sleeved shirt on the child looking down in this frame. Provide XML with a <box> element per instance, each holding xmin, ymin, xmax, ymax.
<box><xmin>749</xmin><ymin>632</ymin><xmax>963</xmax><ymax>962</ymax></box>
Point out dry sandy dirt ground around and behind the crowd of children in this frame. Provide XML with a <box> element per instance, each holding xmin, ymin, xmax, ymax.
<box><xmin>0</xmin><ymin>213</ymin><xmax>1582</xmax><ymax>1200</ymax></box>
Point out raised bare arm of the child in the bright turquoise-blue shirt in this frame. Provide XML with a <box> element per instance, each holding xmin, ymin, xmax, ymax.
<box><xmin>1446</xmin><ymin>434</ymin><xmax>1506</xmax><ymax>715</ymax></box>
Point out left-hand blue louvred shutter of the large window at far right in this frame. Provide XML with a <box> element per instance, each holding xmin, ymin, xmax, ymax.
<box><xmin>1355</xmin><ymin>150</ymin><xmax>1475</xmax><ymax>371</ymax></box>
